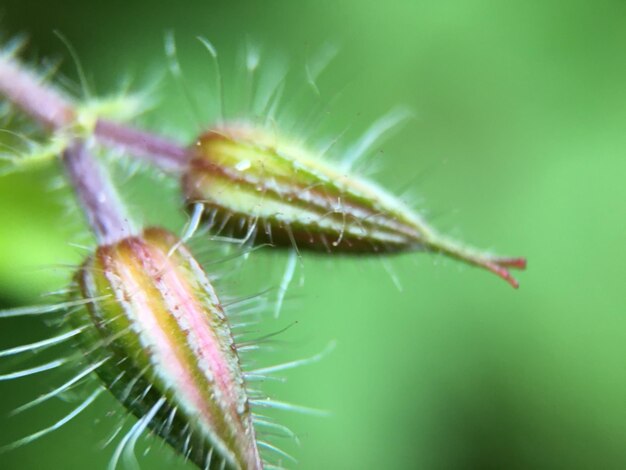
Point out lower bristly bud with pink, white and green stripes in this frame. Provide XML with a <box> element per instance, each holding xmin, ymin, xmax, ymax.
<box><xmin>73</xmin><ymin>229</ymin><xmax>263</xmax><ymax>470</ymax></box>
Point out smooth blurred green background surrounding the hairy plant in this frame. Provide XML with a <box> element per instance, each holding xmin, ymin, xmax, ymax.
<box><xmin>0</xmin><ymin>0</ymin><xmax>626</xmax><ymax>470</ymax></box>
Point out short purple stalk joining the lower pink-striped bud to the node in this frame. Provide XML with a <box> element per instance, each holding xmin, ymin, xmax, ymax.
<box><xmin>63</xmin><ymin>139</ymin><xmax>133</xmax><ymax>244</ymax></box>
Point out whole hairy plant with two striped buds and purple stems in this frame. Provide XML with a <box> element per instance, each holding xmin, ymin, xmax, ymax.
<box><xmin>0</xmin><ymin>35</ymin><xmax>526</xmax><ymax>470</ymax></box>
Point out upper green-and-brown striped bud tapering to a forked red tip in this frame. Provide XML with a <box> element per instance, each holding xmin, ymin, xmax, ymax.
<box><xmin>182</xmin><ymin>125</ymin><xmax>526</xmax><ymax>287</ymax></box>
